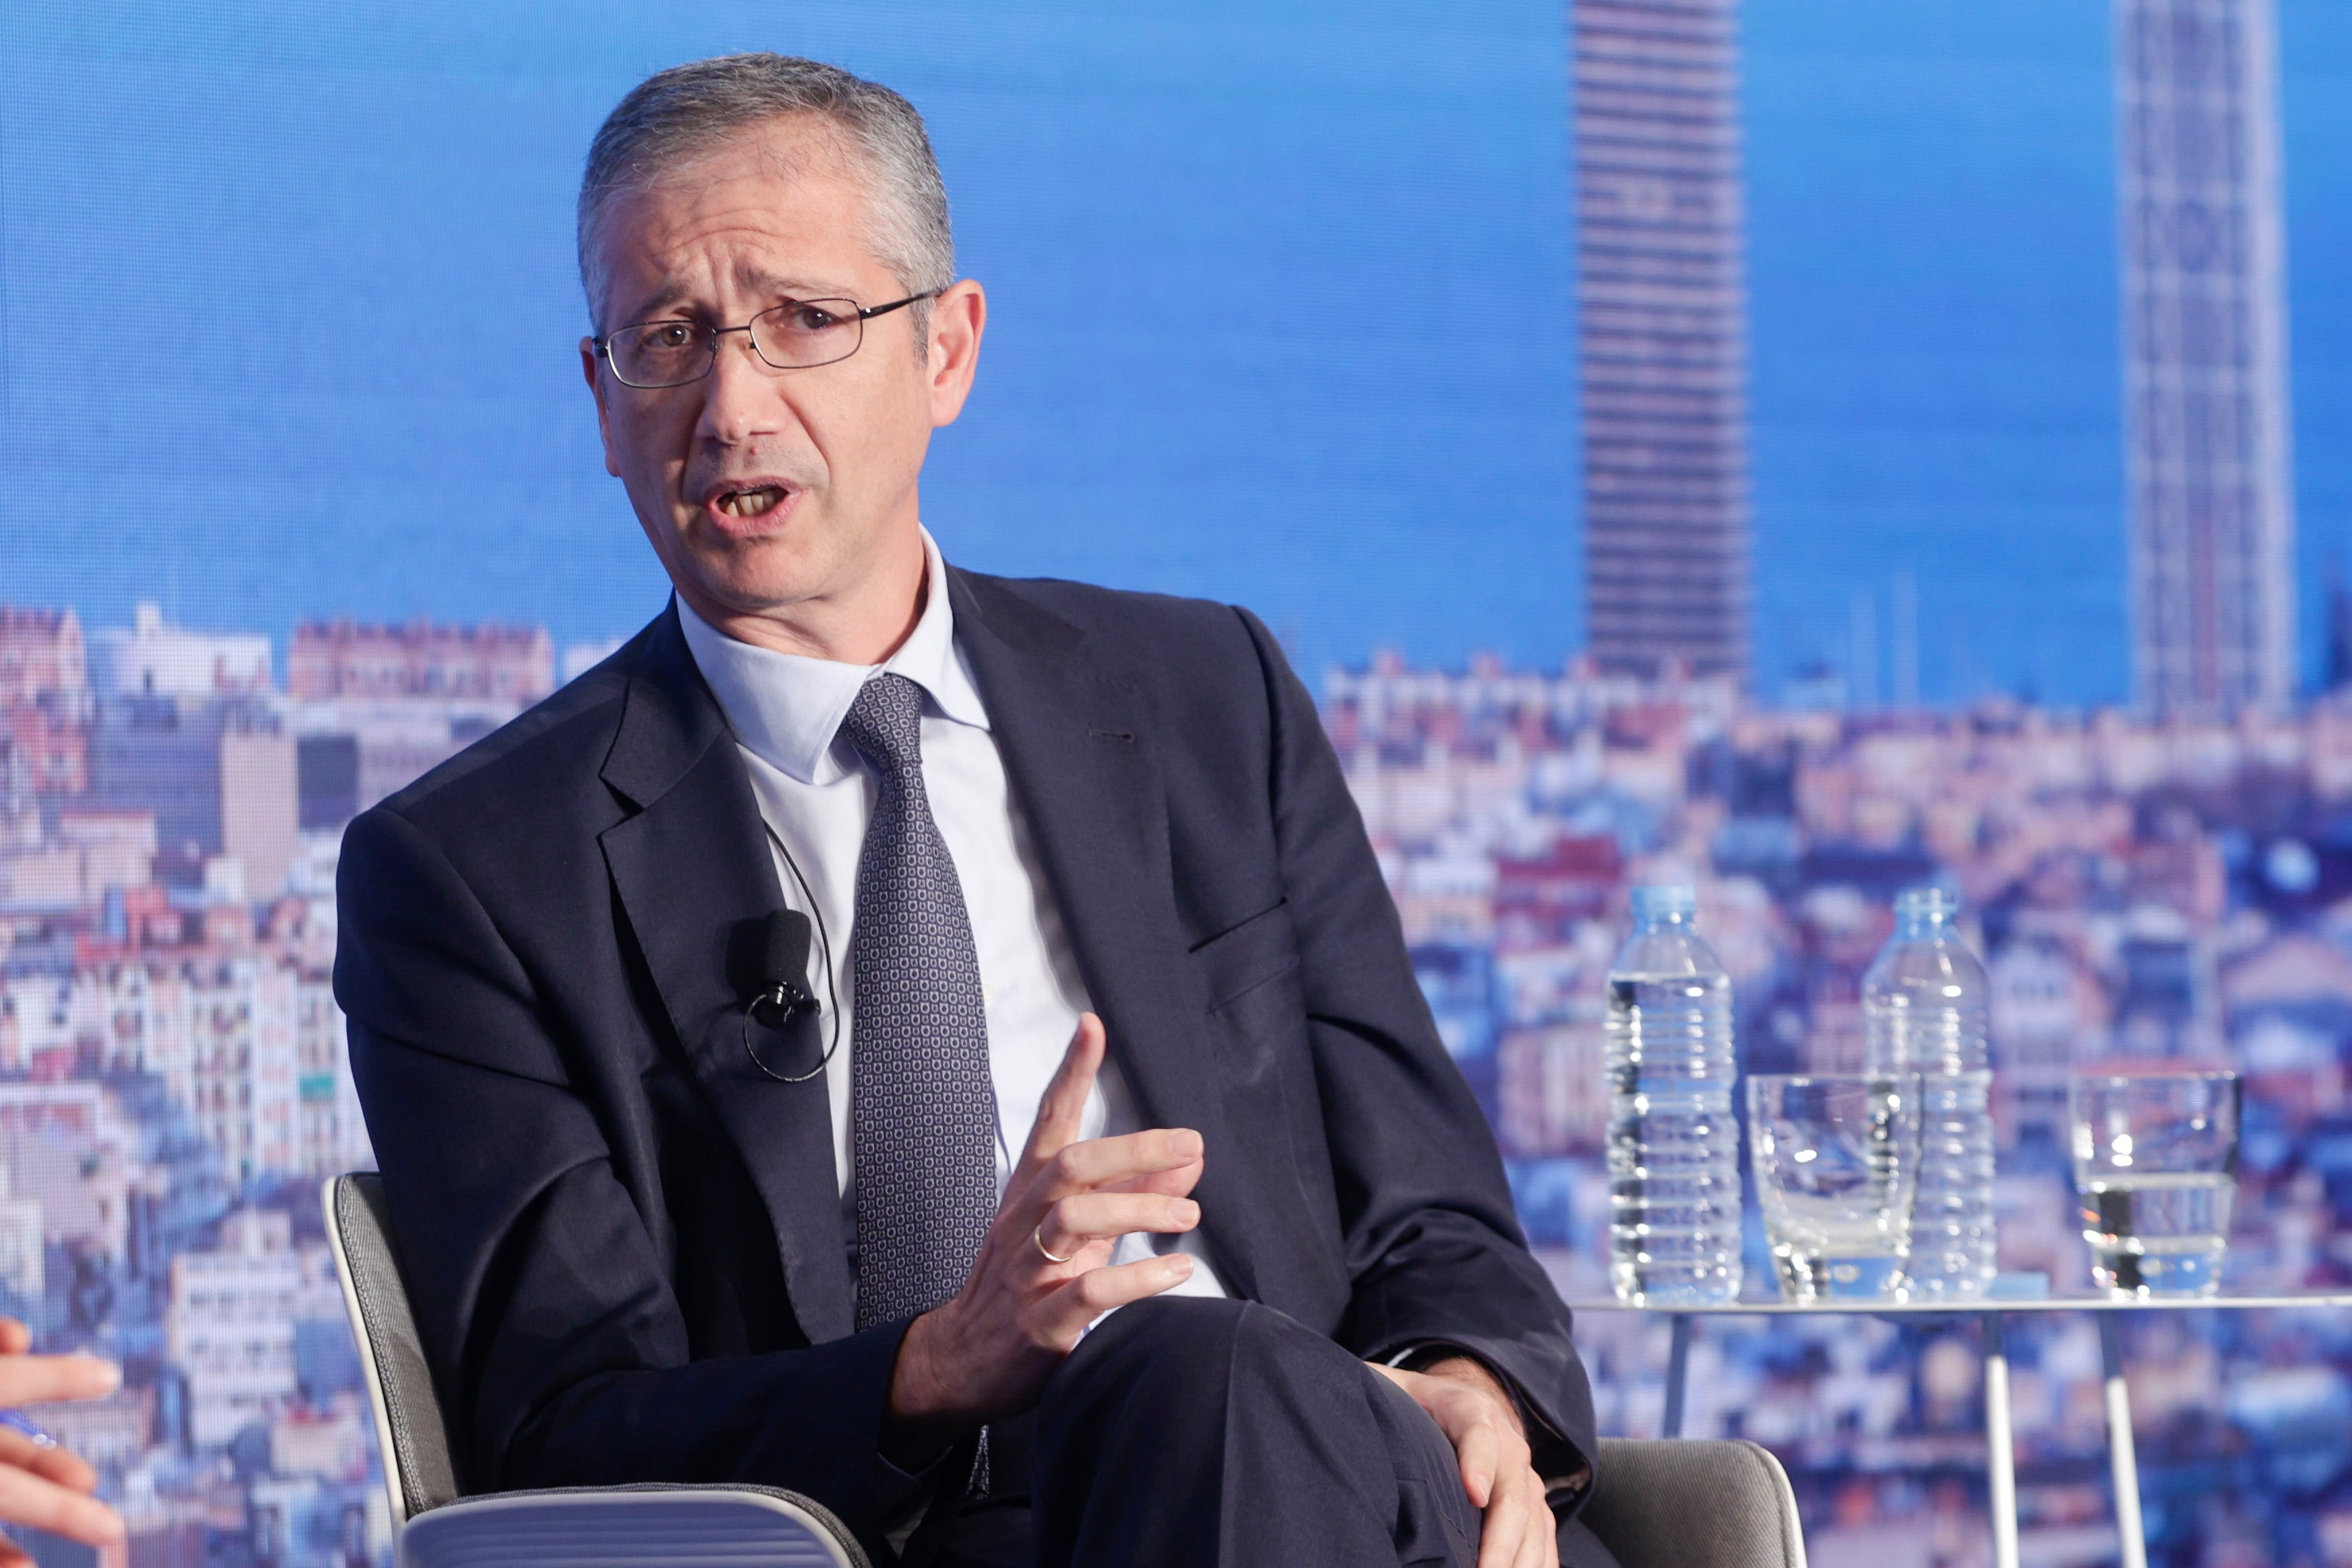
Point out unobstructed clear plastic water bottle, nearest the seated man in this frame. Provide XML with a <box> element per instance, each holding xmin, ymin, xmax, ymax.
<box><xmin>1606</xmin><ymin>886</ymin><xmax>1740</xmax><ymax>1307</ymax></box>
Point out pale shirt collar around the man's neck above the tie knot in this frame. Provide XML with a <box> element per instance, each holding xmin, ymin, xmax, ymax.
<box><xmin>677</xmin><ymin>529</ymin><xmax>988</xmax><ymax>783</ymax></box>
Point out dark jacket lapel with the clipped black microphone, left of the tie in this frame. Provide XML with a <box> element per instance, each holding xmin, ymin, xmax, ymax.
<box><xmin>600</xmin><ymin>606</ymin><xmax>851</xmax><ymax>1342</ymax></box>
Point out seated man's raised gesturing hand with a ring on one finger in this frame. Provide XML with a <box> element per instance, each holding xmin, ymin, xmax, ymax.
<box><xmin>882</xmin><ymin>1013</ymin><xmax>1204</xmax><ymax>1469</ymax></box>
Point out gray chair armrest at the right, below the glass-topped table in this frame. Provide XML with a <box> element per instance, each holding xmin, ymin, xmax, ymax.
<box><xmin>1578</xmin><ymin>1436</ymin><xmax>1804</xmax><ymax>1568</ymax></box>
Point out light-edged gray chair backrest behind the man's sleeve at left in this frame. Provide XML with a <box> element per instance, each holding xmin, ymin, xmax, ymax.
<box><xmin>320</xmin><ymin>1170</ymin><xmax>463</xmax><ymax>1526</ymax></box>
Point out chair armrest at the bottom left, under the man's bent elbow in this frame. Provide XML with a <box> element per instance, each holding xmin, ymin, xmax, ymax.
<box><xmin>400</xmin><ymin>1486</ymin><xmax>873</xmax><ymax>1568</ymax></box>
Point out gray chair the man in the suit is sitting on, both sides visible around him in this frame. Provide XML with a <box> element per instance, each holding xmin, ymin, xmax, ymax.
<box><xmin>322</xmin><ymin>1175</ymin><xmax>1804</xmax><ymax>1568</ymax></box>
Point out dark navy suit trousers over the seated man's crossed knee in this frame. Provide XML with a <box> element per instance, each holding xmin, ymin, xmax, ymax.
<box><xmin>908</xmin><ymin>1298</ymin><xmax>1614</xmax><ymax>1568</ymax></box>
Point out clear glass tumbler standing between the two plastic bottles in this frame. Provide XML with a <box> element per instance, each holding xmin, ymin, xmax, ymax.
<box><xmin>1748</xmin><ymin>1072</ymin><xmax>1919</xmax><ymax>1302</ymax></box>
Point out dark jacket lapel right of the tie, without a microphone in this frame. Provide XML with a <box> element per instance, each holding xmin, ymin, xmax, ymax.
<box><xmin>948</xmin><ymin>567</ymin><xmax>1256</xmax><ymax>1296</ymax></box>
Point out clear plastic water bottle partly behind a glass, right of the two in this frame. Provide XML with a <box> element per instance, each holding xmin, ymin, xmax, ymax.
<box><xmin>1863</xmin><ymin>889</ymin><xmax>1997</xmax><ymax>1298</ymax></box>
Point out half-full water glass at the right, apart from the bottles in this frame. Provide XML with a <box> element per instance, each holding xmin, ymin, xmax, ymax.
<box><xmin>2068</xmin><ymin>1072</ymin><xmax>2239</xmax><ymax>1300</ymax></box>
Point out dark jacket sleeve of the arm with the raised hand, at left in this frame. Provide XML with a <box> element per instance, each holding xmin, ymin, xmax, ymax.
<box><xmin>334</xmin><ymin>806</ymin><xmax>906</xmax><ymax>1540</ymax></box>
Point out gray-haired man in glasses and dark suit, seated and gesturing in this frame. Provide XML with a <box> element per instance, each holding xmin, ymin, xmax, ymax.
<box><xmin>337</xmin><ymin>56</ymin><xmax>1606</xmax><ymax>1568</ymax></box>
